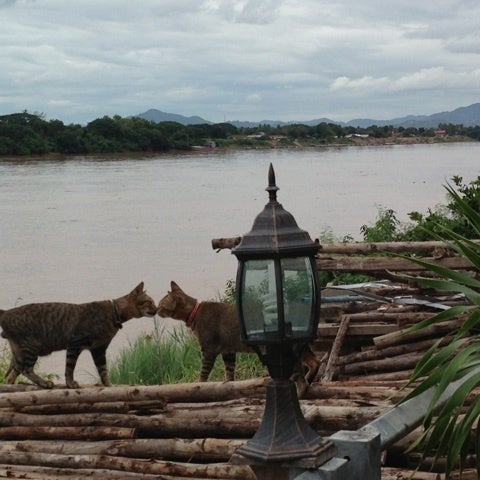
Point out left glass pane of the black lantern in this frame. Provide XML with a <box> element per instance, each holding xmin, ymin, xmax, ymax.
<box><xmin>241</xmin><ymin>259</ymin><xmax>279</xmax><ymax>340</ymax></box>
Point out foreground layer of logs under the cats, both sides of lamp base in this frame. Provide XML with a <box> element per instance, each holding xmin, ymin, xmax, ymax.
<box><xmin>0</xmin><ymin>378</ymin><xmax>395</xmax><ymax>480</ymax></box>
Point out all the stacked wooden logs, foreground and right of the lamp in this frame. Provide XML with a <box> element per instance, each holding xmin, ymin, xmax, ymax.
<box><xmin>0</xmin><ymin>239</ymin><xmax>478</xmax><ymax>480</ymax></box>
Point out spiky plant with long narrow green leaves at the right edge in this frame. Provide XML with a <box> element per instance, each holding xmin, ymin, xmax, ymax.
<box><xmin>404</xmin><ymin>184</ymin><xmax>480</xmax><ymax>478</ymax></box>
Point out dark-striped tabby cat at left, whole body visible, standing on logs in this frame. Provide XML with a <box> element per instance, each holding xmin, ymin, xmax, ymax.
<box><xmin>0</xmin><ymin>282</ymin><xmax>156</xmax><ymax>388</ymax></box>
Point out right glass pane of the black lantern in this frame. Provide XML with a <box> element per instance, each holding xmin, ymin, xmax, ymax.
<box><xmin>281</xmin><ymin>257</ymin><xmax>315</xmax><ymax>337</ymax></box>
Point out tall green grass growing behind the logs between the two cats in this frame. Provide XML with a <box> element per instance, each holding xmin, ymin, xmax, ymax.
<box><xmin>109</xmin><ymin>320</ymin><xmax>266</xmax><ymax>385</ymax></box>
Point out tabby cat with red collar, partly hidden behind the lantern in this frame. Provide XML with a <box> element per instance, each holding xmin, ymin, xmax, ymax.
<box><xmin>157</xmin><ymin>281</ymin><xmax>320</xmax><ymax>395</ymax></box>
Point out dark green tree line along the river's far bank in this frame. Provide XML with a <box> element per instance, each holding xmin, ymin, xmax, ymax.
<box><xmin>0</xmin><ymin>111</ymin><xmax>480</xmax><ymax>156</ymax></box>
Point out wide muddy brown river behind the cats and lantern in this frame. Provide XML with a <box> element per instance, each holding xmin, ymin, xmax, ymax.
<box><xmin>0</xmin><ymin>143</ymin><xmax>480</xmax><ymax>382</ymax></box>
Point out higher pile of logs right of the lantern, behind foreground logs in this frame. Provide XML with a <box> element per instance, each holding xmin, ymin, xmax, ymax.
<box><xmin>212</xmin><ymin>237</ymin><xmax>479</xmax><ymax>478</ymax></box>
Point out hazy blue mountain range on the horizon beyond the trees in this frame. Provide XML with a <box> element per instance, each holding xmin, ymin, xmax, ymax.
<box><xmin>133</xmin><ymin>103</ymin><xmax>480</xmax><ymax>128</ymax></box>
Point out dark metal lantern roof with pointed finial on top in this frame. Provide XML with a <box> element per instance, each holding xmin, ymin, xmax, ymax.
<box><xmin>232</xmin><ymin>164</ymin><xmax>320</xmax><ymax>258</ymax></box>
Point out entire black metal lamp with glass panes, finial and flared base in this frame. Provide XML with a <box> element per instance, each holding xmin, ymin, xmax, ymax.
<box><xmin>232</xmin><ymin>164</ymin><xmax>335</xmax><ymax>468</ymax></box>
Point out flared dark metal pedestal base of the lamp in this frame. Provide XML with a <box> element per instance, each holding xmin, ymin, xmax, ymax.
<box><xmin>231</xmin><ymin>379</ymin><xmax>335</xmax><ymax>468</ymax></box>
